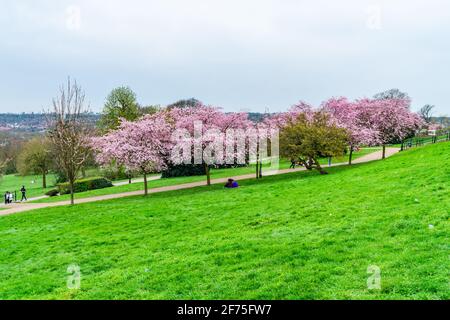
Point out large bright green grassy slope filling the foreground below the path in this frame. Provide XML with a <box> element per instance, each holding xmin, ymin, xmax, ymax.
<box><xmin>0</xmin><ymin>143</ymin><xmax>450</xmax><ymax>299</ymax></box>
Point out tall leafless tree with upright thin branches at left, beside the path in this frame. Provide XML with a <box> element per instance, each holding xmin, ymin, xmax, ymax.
<box><xmin>47</xmin><ymin>78</ymin><xmax>91</xmax><ymax>204</ymax></box>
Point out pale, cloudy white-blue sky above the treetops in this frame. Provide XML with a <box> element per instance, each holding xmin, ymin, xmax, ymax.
<box><xmin>0</xmin><ymin>0</ymin><xmax>450</xmax><ymax>114</ymax></box>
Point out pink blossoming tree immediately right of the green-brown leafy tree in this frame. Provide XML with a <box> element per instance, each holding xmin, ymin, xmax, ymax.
<box><xmin>322</xmin><ymin>97</ymin><xmax>380</xmax><ymax>165</ymax></box>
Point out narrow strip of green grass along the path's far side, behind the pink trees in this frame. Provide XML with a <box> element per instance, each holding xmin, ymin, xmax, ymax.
<box><xmin>33</xmin><ymin>148</ymin><xmax>380</xmax><ymax>203</ymax></box>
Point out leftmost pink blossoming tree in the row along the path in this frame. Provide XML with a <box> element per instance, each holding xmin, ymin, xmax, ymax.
<box><xmin>92</xmin><ymin>114</ymin><xmax>172</xmax><ymax>195</ymax></box>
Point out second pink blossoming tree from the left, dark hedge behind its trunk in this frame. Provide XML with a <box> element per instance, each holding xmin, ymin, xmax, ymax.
<box><xmin>167</xmin><ymin>104</ymin><xmax>251</xmax><ymax>185</ymax></box>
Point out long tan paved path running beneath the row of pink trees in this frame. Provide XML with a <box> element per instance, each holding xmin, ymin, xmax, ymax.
<box><xmin>0</xmin><ymin>148</ymin><xmax>400</xmax><ymax>216</ymax></box>
